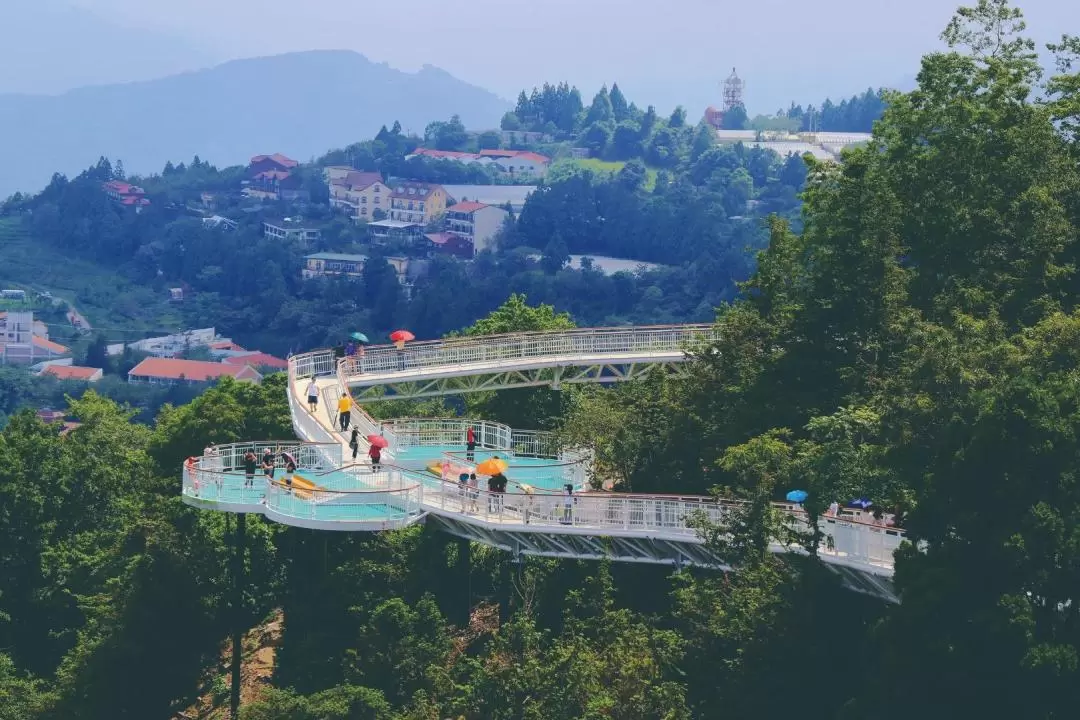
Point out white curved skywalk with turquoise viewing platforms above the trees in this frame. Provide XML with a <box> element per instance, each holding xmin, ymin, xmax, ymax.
<box><xmin>184</xmin><ymin>326</ymin><xmax>904</xmax><ymax>601</ymax></box>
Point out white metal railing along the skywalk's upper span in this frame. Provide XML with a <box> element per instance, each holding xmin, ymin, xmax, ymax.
<box><xmin>332</xmin><ymin>325</ymin><xmax>717</xmax><ymax>382</ymax></box>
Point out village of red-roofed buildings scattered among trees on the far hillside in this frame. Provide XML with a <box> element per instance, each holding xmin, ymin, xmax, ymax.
<box><xmin>0</xmin><ymin>79</ymin><xmax>869</xmax><ymax>423</ymax></box>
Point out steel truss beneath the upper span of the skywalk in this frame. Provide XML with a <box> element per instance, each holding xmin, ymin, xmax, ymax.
<box><xmin>349</xmin><ymin>359</ymin><xmax>685</xmax><ymax>403</ymax></box>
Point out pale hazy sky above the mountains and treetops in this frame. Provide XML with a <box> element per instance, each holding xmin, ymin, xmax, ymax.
<box><xmin>70</xmin><ymin>0</ymin><xmax>1080</xmax><ymax>113</ymax></box>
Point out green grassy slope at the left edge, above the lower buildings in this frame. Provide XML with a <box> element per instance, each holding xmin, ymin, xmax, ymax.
<box><xmin>0</xmin><ymin>218</ymin><xmax>181</xmax><ymax>342</ymax></box>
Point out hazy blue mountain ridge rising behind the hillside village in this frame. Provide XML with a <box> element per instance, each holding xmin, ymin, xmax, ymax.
<box><xmin>0</xmin><ymin>51</ymin><xmax>511</xmax><ymax>198</ymax></box>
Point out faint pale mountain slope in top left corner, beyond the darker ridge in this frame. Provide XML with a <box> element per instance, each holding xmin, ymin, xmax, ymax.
<box><xmin>0</xmin><ymin>0</ymin><xmax>215</xmax><ymax>95</ymax></box>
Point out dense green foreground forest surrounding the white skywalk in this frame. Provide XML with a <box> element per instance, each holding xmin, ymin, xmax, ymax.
<box><xmin>0</xmin><ymin>0</ymin><xmax>1080</xmax><ymax>720</ymax></box>
